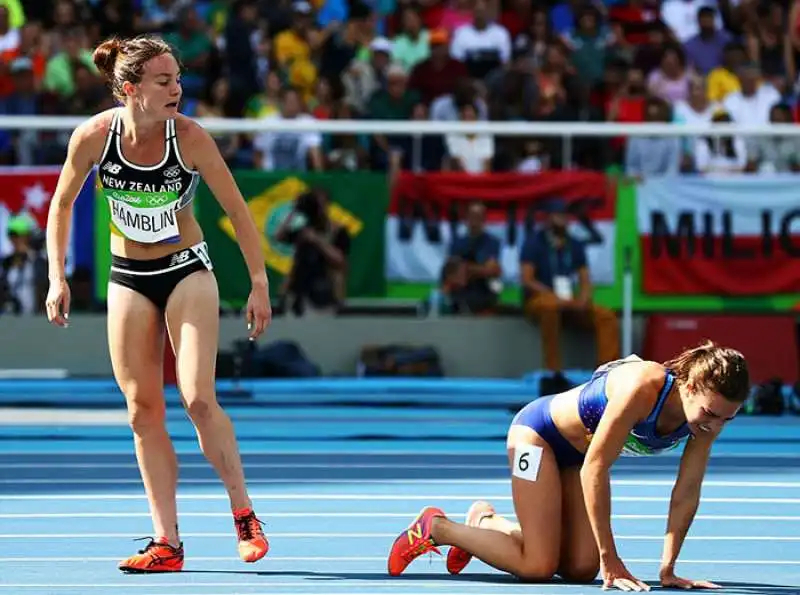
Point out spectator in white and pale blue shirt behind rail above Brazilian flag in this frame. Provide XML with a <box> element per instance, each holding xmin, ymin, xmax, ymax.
<box><xmin>253</xmin><ymin>87</ymin><xmax>323</xmax><ymax>171</ymax></box>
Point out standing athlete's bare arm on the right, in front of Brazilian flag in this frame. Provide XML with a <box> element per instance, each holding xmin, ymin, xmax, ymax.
<box><xmin>175</xmin><ymin>117</ymin><xmax>272</xmax><ymax>338</ymax></box>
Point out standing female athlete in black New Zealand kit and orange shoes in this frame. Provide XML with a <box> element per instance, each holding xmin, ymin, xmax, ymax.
<box><xmin>47</xmin><ymin>37</ymin><xmax>271</xmax><ymax>572</ymax></box>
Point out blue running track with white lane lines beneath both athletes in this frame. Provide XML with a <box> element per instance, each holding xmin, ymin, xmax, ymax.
<box><xmin>0</xmin><ymin>381</ymin><xmax>800</xmax><ymax>595</ymax></box>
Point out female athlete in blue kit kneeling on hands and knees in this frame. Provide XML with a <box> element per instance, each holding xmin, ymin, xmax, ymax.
<box><xmin>389</xmin><ymin>343</ymin><xmax>750</xmax><ymax>591</ymax></box>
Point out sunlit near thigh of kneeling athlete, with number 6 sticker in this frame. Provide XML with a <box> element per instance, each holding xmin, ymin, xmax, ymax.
<box><xmin>506</xmin><ymin>425</ymin><xmax>561</xmax><ymax>575</ymax></box>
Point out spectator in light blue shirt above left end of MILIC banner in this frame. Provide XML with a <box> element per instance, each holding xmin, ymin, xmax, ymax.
<box><xmin>625</xmin><ymin>97</ymin><xmax>682</xmax><ymax>181</ymax></box>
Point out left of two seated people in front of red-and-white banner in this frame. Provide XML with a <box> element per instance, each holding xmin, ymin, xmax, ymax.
<box><xmin>448</xmin><ymin>202</ymin><xmax>502</xmax><ymax>314</ymax></box>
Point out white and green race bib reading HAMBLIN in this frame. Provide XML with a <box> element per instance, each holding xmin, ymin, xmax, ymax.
<box><xmin>106</xmin><ymin>190</ymin><xmax>180</xmax><ymax>244</ymax></box>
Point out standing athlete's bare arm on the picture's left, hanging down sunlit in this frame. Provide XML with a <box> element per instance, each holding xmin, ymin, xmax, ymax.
<box><xmin>47</xmin><ymin>113</ymin><xmax>108</xmax><ymax>326</ymax></box>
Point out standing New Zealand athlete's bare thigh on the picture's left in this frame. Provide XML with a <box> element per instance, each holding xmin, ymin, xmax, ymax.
<box><xmin>107</xmin><ymin>283</ymin><xmax>164</xmax><ymax>406</ymax></box>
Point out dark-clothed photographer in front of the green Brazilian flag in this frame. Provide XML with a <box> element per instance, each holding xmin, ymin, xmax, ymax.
<box><xmin>277</xmin><ymin>190</ymin><xmax>350</xmax><ymax>316</ymax></box>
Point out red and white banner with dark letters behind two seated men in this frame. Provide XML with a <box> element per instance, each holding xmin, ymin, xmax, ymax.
<box><xmin>386</xmin><ymin>171</ymin><xmax>616</xmax><ymax>285</ymax></box>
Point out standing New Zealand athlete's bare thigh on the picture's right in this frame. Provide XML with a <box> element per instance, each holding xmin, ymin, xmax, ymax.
<box><xmin>167</xmin><ymin>271</ymin><xmax>219</xmax><ymax>402</ymax></box>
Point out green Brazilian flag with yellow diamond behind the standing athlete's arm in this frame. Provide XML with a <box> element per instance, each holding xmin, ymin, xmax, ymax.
<box><xmin>197</xmin><ymin>171</ymin><xmax>388</xmax><ymax>303</ymax></box>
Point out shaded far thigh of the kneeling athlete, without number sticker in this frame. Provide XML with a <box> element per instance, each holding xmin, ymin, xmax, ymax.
<box><xmin>558</xmin><ymin>467</ymin><xmax>600</xmax><ymax>582</ymax></box>
